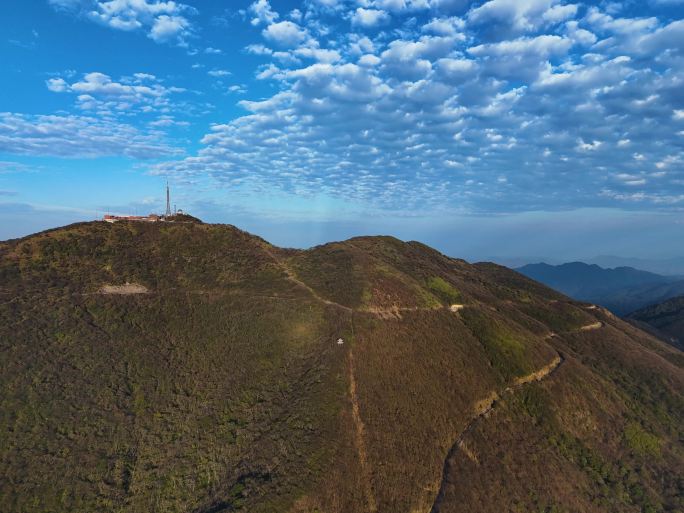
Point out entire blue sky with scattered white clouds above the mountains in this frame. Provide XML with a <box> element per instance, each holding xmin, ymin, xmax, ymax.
<box><xmin>0</xmin><ymin>0</ymin><xmax>684</xmax><ymax>260</ymax></box>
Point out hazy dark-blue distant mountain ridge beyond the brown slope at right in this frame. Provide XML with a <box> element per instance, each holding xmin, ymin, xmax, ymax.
<box><xmin>517</xmin><ymin>262</ymin><xmax>684</xmax><ymax>315</ymax></box>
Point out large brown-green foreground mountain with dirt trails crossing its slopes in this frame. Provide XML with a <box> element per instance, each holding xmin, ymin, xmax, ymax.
<box><xmin>0</xmin><ymin>222</ymin><xmax>684</xmax><ymax>513</ymax></box>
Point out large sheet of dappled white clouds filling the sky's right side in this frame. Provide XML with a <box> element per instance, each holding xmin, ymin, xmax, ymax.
<box><xmin>143</xmin><ymin>0</ymin><xmax>684</xmax><ymax>212</ymax></box>
